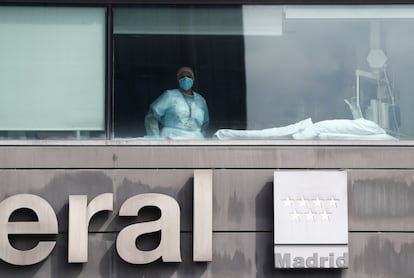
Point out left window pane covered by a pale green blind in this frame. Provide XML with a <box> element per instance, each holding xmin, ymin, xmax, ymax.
<box><xmin>0</xmin><ymin>6</ymin><xmax>105</xmax><ymax>139</ymax></box>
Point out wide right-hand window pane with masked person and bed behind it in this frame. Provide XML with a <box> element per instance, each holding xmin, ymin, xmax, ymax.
<box><xmin>113</xmin><ymin>5</ymin><xmax>414</xmax><ymax>140</ymax></box>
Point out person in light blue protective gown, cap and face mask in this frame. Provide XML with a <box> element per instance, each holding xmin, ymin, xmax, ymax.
<box><xmin>145</xmin><ymin>67</ymin><xmax>209</xmax><ymax>139</ymax></box>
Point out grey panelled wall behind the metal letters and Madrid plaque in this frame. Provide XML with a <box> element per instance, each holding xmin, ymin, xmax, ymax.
<box><xmin>0</xmin><ymin>146</ymin><xmax>414</xmax><ymax>278</ymax></box>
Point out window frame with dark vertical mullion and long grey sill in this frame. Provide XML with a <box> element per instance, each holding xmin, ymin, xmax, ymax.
<box><xmin>0</xmin><ymin>0</ymin><xmax>414</xmax><ymax>146</ymax></box>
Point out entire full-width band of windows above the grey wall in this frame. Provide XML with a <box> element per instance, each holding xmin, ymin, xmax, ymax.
<box><xmin>0</xmin><ymin>5</ymin><xmax>414</xmax><ymax>140</ymax></box>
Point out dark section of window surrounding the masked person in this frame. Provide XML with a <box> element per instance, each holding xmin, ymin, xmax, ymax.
<box><xmin>113</xmin><ymin>6</ymin><xmax>246</xmax><ymax>139</ymax></box>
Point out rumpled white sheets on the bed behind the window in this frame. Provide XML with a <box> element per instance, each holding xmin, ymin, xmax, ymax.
<box><xmin>214</xmin><ymin>118</ymin><xmax>397</xmax><ymax>140</ymax></box>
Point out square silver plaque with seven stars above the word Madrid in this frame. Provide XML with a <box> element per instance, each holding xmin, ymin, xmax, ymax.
<box><xmin>273</xmin><ymin>171</ymin><xmax>348</xmax><ymax>268</ymax></box>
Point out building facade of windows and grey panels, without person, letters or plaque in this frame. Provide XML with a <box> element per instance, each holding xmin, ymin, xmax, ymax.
<box><xmin>0</xmin><ymin>0</ymin><xmax>414</xmax><ymax>277</ymax></box>
